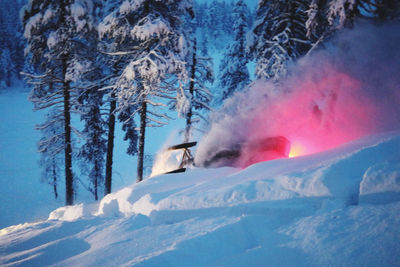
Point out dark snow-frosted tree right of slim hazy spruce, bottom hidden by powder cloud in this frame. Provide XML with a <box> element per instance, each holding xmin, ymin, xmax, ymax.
<box><xmin>249</xmin><ymin>0</ymin><xmax>310</xmax><ymax>82</ymax></box>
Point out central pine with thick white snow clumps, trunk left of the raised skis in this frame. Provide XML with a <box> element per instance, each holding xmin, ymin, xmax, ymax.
<box><xmin>99</xmin><ymin>0</ymin><xmax>192</xmax><ymax>182</ymax></box>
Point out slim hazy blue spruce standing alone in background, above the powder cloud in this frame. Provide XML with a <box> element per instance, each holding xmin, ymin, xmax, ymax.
<box><xmin>219</xmin><ymin>0</ymin><xmax>250</xmax><ymax>100</ymax></box>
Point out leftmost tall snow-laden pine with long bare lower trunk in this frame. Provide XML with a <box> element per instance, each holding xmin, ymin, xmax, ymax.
<box><xmin>22</xmin><ymin>0</ymin><xmax>98</xmax><ymax>205</ymax></box>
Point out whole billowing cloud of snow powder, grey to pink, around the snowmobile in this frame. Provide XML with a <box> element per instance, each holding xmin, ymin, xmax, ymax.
<box><xmin>196</xmin><ymin>24</ymin><xmax>400</xmax><ymax>165</ymax></box>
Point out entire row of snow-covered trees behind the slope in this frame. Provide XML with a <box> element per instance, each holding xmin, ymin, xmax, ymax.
<box><xmin>12</xmin><ymin>0</ymin><xmax>400</xmax><ymax>205</ymax></box>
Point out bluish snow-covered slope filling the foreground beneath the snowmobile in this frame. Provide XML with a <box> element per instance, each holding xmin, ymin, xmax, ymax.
<box><xmin>0</xmin><ymin>132</ymin><xmax>400</xmax><ymax>266</ymax></box>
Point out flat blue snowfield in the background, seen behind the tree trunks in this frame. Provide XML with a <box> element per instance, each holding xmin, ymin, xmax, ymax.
<box><xmin>0</xmin><ymin>90</ymin><xmax>182</xmax><ymax>229</ymax></box>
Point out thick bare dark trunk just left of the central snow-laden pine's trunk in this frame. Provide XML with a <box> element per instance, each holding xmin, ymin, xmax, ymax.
<box><xmin>104</xmin><ymin>92</ymin><xmax>117</xmax><ymax>195</ymax></box>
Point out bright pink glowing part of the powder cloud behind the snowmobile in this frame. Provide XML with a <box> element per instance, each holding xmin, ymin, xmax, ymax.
<box><xmin>248</xmin><ymin>63</ymin><xmax>378</xmax><ymax>157</ymax></box>
